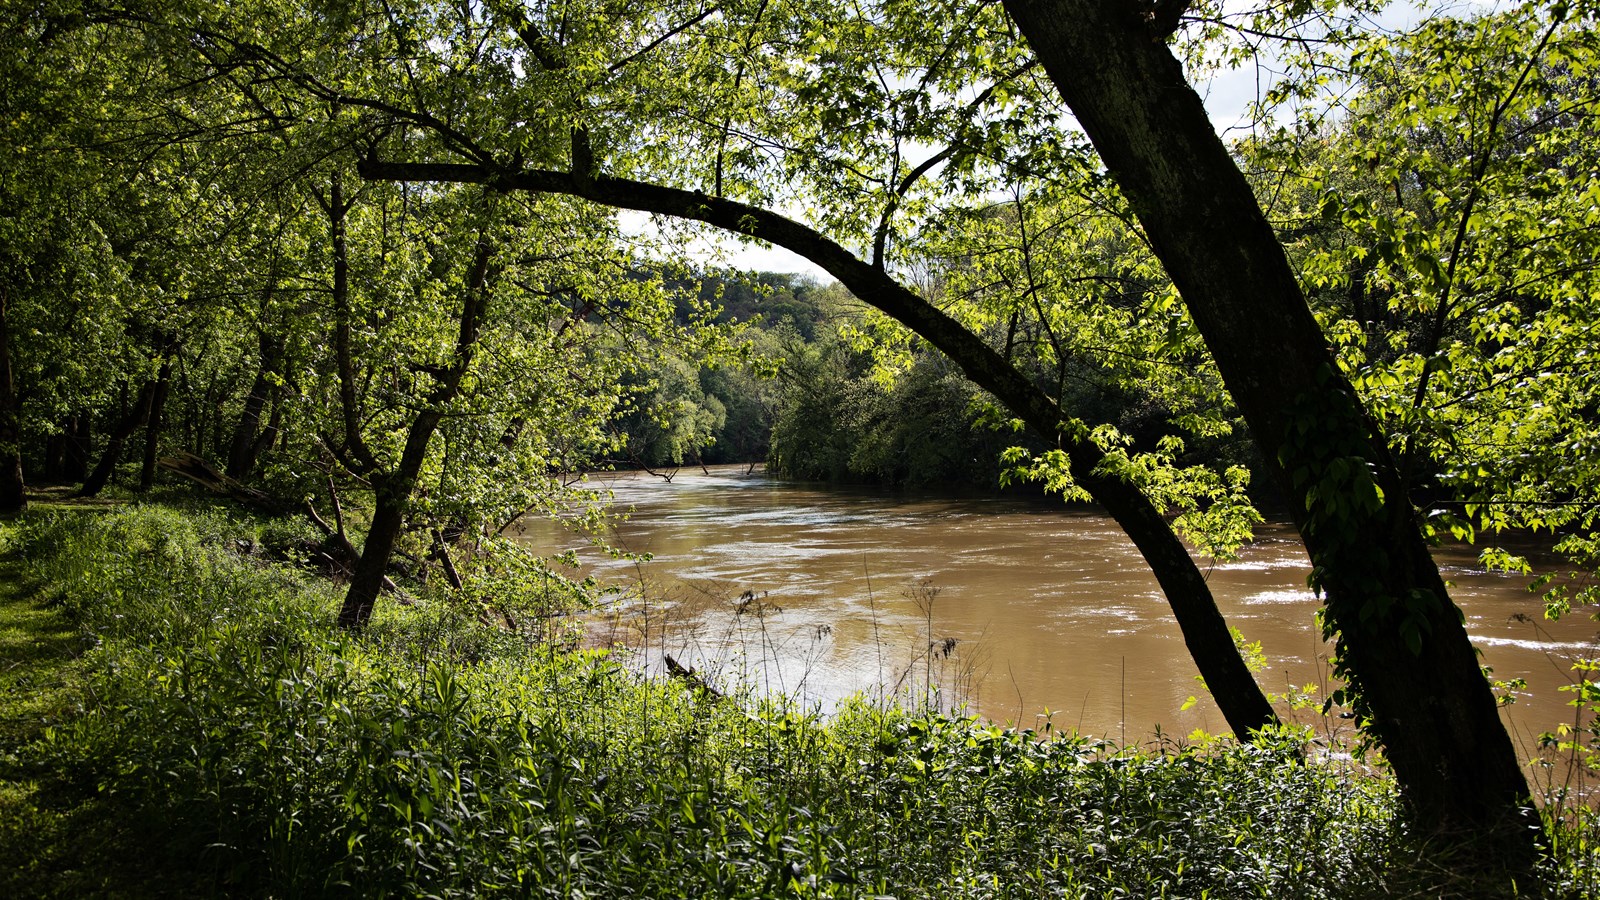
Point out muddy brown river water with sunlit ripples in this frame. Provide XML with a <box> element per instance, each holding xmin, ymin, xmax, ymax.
<box><xmin>523</xmin><ymin>466</ymin><xmax>1600</xmax><ymax>757</ymax></box>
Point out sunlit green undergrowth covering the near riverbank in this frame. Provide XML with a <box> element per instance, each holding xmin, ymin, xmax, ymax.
<box><xmin>0</xmin><ymin>506</ymin><xmax>1592</xmax><ymax>898</ymax></box>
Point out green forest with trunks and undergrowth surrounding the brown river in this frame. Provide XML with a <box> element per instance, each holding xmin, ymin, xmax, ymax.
<box><xmin>0</xmin><ymin>0</ymin><xmax>1600</xmax><ymax>897</ymax></box>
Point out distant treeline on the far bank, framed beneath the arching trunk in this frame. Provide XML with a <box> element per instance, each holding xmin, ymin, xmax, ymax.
<box><xmin>614</xmin><ymin>272</ymin><xmax>1264</xmax><ymax>490</ymax></box>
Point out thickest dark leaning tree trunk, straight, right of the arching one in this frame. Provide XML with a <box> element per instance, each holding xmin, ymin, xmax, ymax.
<box><xmin>1005</xmin><ymin>0</ymin><xmax>1538</xmax><ymax>858</ymax></box>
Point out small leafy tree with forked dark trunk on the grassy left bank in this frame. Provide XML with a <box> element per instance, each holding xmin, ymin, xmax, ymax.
<box><xmin>290</xmin><ymin>168</ymin><xmax>700</xmax><ymax>628</ymax></box>
